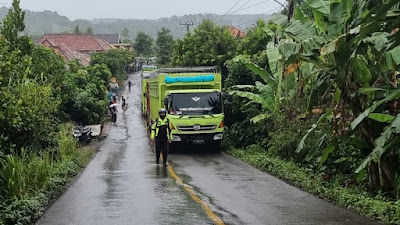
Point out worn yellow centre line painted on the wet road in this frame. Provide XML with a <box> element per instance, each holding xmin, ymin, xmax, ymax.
<box><xmin>168</xmin><ymin>165</ymin><xmax>224</xmax><ymax>225</ymax></box>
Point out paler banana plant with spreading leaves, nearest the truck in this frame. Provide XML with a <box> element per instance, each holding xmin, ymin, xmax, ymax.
<box><xmin>231</xmin><ymin>14</ymin><xmax>316</xmax><ymax>122</ymax></box>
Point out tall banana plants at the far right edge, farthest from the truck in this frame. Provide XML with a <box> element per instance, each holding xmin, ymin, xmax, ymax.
<box><xmin>292</xmin><ymin>0</ymin><xmax>400</xmax><ymax>190</ymax></box>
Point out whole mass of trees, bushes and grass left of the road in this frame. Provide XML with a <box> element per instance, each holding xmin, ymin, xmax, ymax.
<box><xmin>0</xmin><ymin>0</ymin><xmax>132</xmax><ymax>224</ymax></box>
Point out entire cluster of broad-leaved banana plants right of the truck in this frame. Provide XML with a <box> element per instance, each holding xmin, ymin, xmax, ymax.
<box><xmin>232</xmin><ymin>0</ymin><xmax>400</xmax><ymax>193</ymax></box>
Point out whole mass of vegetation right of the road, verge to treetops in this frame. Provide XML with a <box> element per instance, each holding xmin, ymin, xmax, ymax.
<box><xmin>161</xmin><ymin>0</ymin><xmax>400</xmax><ymax>224</ymax></box>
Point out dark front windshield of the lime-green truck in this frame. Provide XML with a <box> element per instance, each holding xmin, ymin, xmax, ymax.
<box><xmin>169</xmin><ymin>92</ymin><xmax>222</xmax><ymax>115</ymax></box>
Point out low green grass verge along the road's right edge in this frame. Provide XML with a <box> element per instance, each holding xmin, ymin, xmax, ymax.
<box><xmin>226</xmin><ymin>146</ymin><xmax>400</xmax><ymax>224</ymax></box>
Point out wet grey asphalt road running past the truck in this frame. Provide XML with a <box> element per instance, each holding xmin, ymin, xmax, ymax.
<box><xmin>37</xmin><ymin>74</ymin><xmax>380</xmax><ymax>225</ymax></box>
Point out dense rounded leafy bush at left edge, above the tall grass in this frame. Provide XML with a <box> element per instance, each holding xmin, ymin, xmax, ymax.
<box><xmin>0</xmin><ymin>79</ymin><xmax>59</xmax><ymax>154</ymax></box>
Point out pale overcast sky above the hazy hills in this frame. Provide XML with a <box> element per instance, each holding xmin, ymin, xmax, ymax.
<box><xmin>14</xmin><ymin>0</ymin><xmax>284</xmax><ymax>20</ymax></box>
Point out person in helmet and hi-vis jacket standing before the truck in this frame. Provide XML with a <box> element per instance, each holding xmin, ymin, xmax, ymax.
<box><xmin>151</xmin><ymin>109</ymin><xmax>172</xmax><ymax>166</ymax></box>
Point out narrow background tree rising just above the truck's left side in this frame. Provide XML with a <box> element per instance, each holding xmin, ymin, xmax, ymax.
<box><xmin>156</xmin><ymin>27</ymin><xmax>174</xmax><ymax>65</ymax></box>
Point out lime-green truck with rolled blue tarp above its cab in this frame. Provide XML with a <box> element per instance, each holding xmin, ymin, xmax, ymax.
<box><xmin>142</xmin><ymin>67</ymin><xmax>224</xmax><ymax>151</ymax></box>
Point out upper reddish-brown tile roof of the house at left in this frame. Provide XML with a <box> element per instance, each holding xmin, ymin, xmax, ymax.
<box><xmin>38</xmin><ymin>34</ymin><xmax>113</xmax><ymax>52</ymax></box>
